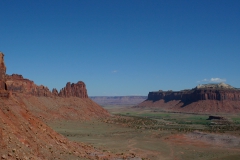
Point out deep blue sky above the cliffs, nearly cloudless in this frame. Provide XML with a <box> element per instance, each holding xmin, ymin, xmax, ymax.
<box><xmin>0</xmin><ymin>0</ymin><xmax>240</xmax><ymax>96</ymax></box>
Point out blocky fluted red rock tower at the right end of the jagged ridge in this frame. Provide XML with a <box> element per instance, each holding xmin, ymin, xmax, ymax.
<box><xmin>58</xmin><ymin>81</ymin><xmax>88</xmax><ymax>98</ymax></box>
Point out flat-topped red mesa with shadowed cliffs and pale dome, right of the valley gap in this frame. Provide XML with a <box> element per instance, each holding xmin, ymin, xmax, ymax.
<box><xmin>136</xmin><ymin>83</ymin><xmax>240</xmax><ymax>113</ymax></box>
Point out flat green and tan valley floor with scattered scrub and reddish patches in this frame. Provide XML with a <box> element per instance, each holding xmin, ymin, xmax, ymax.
<box><xmin>49</xmin><ymin>106</ymin><xmax>240</xmax><ymax>160</ymax></box>
